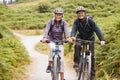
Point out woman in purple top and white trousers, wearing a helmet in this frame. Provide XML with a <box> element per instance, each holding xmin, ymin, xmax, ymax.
<box><xmin>42</xmin><ymin>8</ymin><xmax>72</xmax><ymax>80</ymax></box>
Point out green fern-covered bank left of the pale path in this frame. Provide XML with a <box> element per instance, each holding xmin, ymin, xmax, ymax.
<box><xmin>0</xmin><ymin>5</ymin><xmax>30</xmax><ymax>80</ymax></box>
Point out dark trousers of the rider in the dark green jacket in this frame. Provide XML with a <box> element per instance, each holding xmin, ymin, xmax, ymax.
<box><xmin>74</xmin><ymin>42</ymin><xmax>95</xmax><ymax>76</ymax></box>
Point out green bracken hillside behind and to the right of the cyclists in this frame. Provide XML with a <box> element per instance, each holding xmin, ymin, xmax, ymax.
<box><xmin>0</xmin><ymin>0</ymin><xmax>120</xmax><ymax>80</ymax></box>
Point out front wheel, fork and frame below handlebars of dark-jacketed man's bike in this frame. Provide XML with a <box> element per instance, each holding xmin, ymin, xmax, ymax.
<box><xmin>78</xmin><ymin>43</ymin><xmax>91</xmax><ymax>80</ymax></box>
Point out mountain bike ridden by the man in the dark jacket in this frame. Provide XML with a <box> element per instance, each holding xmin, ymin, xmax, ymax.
<box><xmin>76</xmin><ymin>39</ymin><xmax>100</xmax><ymax>80</ymax></box>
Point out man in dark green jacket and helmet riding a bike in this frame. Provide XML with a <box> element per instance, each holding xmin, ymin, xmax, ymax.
<box><xmin>71</xmin><ymin>6</ymin><xmax>105</xmax><ymax>80</ymax></box>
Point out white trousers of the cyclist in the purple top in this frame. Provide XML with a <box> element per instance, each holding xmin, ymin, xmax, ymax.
<box><xmin>48</xmin><ymin>42</ymin><xmax>64</xmax><ymax>72</ymax></box>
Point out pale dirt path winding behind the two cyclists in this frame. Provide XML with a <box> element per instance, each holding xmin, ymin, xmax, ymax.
<box><xmin>14</xmin><ymin>33</ymin><xmax>75</xmax><ymax>80</ymax></box>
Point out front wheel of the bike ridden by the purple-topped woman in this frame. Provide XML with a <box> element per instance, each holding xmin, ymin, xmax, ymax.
<box><xmin>52</xmin><ymin>55</ymin><xmax>60</xmax><ymax>80</ymax></box>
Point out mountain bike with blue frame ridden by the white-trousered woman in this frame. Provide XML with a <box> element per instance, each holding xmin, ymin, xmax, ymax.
<box><xmin>42</xmin><ymin>40</ymin><xmax>67</xmax><ymax>80</ymax></box>
